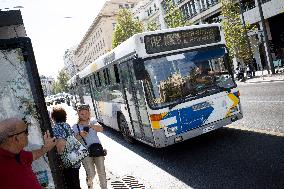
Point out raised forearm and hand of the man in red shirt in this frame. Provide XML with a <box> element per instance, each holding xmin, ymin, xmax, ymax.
<box><xmin>32</xmin><ymin>130</ymin><xmax>56</xmax><ymax>160</ymax></box>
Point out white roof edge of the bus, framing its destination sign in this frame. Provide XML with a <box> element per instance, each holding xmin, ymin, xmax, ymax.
<box><xmin>76</xmin><ymin>23</ymin><xmax>225</xmax><ymax>79</ymax></box>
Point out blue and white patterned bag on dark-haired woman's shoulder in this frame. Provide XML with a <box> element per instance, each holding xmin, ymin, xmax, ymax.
<box><xmin>61</xmin><ymin>123</ymin><xmax>89</xmax><ymax>168</ymax></box>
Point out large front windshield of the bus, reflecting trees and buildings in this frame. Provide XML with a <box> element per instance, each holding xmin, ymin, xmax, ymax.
<box><xmin>144</xmin><ymin>47</ymin><xmax>236</xmax><ymax>108</ymax></box>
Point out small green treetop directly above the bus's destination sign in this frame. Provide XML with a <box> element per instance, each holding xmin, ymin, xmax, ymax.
<box><xmin>165</xmin><ymin>0</ymin><xmax>190</xmax><ymax>28</ymax></box>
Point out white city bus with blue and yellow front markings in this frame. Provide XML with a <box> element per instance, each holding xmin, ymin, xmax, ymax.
<box><xmin>69</xmin><ymin>24</ymin><xmax>243</xmax><ymax>148</ymax></box>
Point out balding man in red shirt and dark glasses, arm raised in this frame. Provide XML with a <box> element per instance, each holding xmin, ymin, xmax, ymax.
<box><xmin>0</xmin><ymin>118</ymin><xmax>56</xmax><ymax>189</ymax></box>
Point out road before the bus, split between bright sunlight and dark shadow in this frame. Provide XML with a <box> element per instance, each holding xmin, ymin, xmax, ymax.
<box><xmin>101</xmin><ymin>125</ymin><xmax>284</xmax><ymax>189</ymax></box>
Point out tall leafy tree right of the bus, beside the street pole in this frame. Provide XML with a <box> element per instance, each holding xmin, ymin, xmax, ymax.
<box><xmin>221</xmin><ymin>0</ymin><xmax>253</xmax><ymax>63</ymax></box>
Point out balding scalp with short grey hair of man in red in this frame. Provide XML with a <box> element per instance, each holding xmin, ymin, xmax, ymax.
<box><xmin>0</xmin><ymin>118</ymin><xmax>19</xmax><ymax>144</ymax></box>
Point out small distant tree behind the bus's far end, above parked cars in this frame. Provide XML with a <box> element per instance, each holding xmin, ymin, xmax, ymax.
<box><xmin>52</xmin><ymin>69</ymin><xmax>70</xmax><ymax>94</ymax></box>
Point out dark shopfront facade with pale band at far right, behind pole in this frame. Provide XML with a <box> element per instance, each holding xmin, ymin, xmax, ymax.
<box><xmin>243</xmin><ymin>0</ymin><xmax>284</xmax><ymax>70</ymax></box>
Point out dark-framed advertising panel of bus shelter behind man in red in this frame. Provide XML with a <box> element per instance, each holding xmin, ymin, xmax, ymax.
<box><xmin>0</xmin><ymin>37</ymin><xmax>63</xmax><ymax>189</ymax></box>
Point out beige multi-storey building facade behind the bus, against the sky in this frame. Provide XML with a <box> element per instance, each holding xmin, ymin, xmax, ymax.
<box><xmin>74</xmin><ymin>0</ymin><xmax>138</xmax><ymax>71</ymax></box>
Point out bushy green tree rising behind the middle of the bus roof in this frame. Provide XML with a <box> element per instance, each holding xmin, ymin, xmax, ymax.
<box><xmin>112</xmin><ymin>9</ymin><xmax>143</xmax><ymax>48</ymax></box>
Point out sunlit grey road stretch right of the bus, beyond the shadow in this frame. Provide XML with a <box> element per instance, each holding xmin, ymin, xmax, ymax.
<box><xmin>233</xmin><ymin>82</ymin><xmax>284</xmax><ymax>134</ymax></box>
